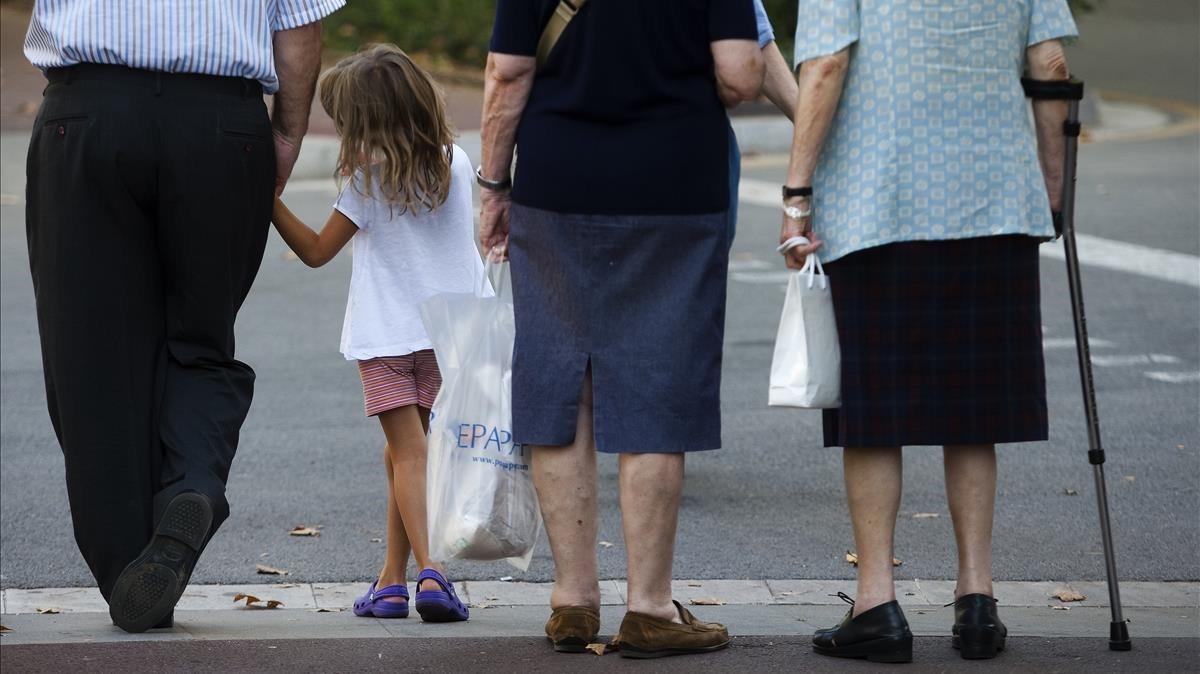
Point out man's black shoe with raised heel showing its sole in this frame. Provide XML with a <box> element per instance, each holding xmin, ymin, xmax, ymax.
<box><xmin>108</xmin><ymin>492</ymin><xmax>212</xmax><ymax>632</ymax></box>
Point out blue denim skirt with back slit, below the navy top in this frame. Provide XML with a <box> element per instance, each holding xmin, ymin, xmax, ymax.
<box><xmin>509</xmin><ymin>199</ymin><xmax>728</xmax><ymax>452</ymax></box>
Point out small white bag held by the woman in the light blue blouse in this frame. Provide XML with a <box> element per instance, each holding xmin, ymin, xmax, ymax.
<box><xmin>768</xmin><ymin>236</ymin><xmax>841</xmax><ymax>409</ymax></box>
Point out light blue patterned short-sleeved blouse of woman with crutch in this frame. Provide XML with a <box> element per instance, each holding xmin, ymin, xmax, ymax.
<box><xmin>796</xmin><ymin>0</ymin><xmax>1076</xmax><ymax>261</ymax></box>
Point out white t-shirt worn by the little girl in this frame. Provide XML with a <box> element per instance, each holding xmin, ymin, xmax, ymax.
<box><xmin>334</xmin><ymin>145</ymin><xmax>484</xmax><ymax>360</ymax></box>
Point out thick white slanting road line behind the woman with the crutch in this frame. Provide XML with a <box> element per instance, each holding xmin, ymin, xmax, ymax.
<box><xmin>738</xmin><ymin>177</ymin><xmax>1200</xmax><ymax>288</ymax></box>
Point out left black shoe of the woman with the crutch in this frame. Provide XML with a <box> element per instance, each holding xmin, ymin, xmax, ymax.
<box><xmin>812</xmin><ymin>592</ymin><xmax>912</xmax><ymax>662</ymax></box>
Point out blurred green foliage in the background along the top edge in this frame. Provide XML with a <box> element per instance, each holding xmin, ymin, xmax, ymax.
<box><xmin>325</xmin><ymin>0</ymin><xmax>1102</xmax><ymax>67</ymax></box>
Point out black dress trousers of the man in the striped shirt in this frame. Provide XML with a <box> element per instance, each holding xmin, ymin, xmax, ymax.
<box><xmin>26</xmin><ymin>65</ymin><xmax>275</xmax><ymax>597</ymax></box>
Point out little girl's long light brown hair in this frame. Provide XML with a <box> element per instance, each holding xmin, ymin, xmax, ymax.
<box><xmin>318</xmin><ymin>44</ymin><xmax>454</xmax><ymax>212</ymax></box>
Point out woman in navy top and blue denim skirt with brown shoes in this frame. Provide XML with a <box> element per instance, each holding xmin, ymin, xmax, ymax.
<box><xmin>479</xmin><ymin>0</ymin><xmax>763</xmax><ymax>657</ymax></box>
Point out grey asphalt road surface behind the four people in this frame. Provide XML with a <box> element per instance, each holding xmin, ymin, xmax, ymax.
<box><xmin>0</xmin><ymin>1</ymin><xmax>1200</xmax><ymax>587</ymax></box>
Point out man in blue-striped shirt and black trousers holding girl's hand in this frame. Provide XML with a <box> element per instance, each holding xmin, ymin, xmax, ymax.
<box><xmin>25</xmin><ymin>0</ymin><xmax>344</xmax><ymax>632</ymax></box>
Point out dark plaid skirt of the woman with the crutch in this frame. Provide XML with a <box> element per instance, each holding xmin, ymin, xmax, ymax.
<box><xmin>824</xmin><ymin>235</ymin><xmax>1048</xmax><ymax>447</ymax></box>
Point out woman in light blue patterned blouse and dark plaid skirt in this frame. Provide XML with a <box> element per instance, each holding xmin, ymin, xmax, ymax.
<box><xmin>780</xmin><ymin>0</ymin><xmax>1075</xmax><ymax>662</ymax></box>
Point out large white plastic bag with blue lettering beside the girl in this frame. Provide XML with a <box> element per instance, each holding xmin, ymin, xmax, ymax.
<box><xmin>420</xmin><ymin>256</ymin><xmax>541</xmax><ymax>570</ymax></box>
